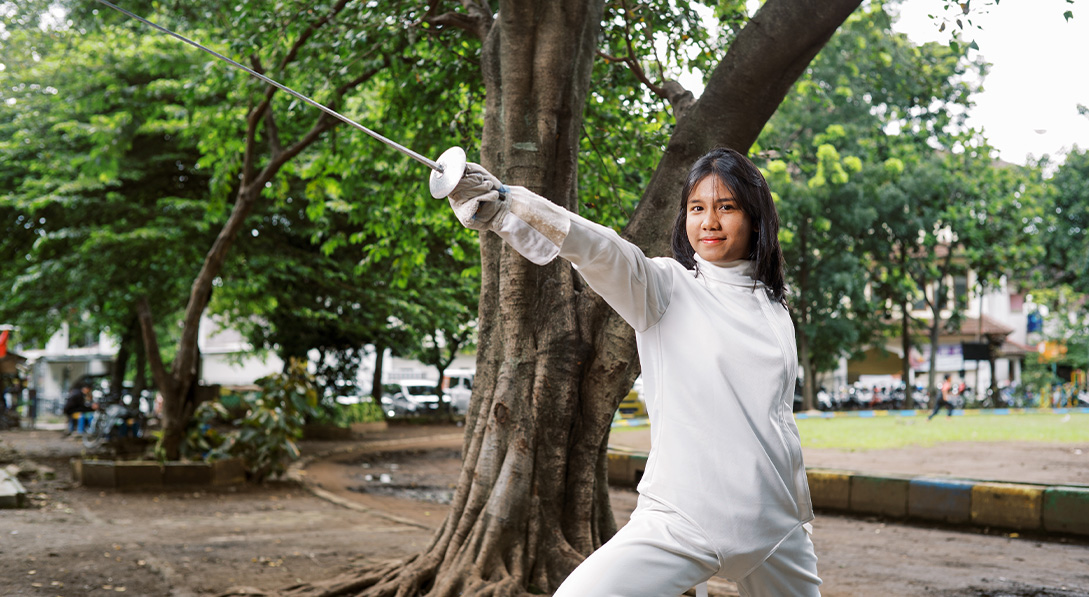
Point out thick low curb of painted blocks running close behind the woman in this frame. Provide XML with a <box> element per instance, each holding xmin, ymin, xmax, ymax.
<box><xmin>609</xmin><ymin>448</ymin><xmax>1089</xmax><ymax>537</ymax></box>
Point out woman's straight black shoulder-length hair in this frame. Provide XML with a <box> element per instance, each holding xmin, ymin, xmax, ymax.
<box><xmin>671</xmin><ymin>147</ymin><xmax>786</xmax><ymax>305</ymax></box>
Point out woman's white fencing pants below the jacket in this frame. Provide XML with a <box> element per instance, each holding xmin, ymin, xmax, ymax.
<box><xmin>553</xmin><ymin>497</ymin><xmax>821</xmax><ymax>597</ymax></box>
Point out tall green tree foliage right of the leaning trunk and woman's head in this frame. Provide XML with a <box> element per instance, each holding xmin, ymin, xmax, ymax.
<box><xmin>755</xmin><ymin>4</ymin><xmax>978</xmax><ymax>379</ymax></box>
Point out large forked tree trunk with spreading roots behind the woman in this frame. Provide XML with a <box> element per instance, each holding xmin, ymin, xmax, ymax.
<box><xmin>261</xmin><ymin>0</ymin><xmax>859</xmax><ymax>597</ymax></box>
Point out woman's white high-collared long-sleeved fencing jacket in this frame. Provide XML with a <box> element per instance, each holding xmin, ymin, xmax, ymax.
<box><xmin>499</xmin><ymin>187</ymin><xmax>812</xmax><ymax>578</ymax></box>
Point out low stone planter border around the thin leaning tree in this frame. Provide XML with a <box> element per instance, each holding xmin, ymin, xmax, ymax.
<box><xmin>72</xmin><ymin>459</ymin><xmax>246</xmax><ymax>491</ymax></box>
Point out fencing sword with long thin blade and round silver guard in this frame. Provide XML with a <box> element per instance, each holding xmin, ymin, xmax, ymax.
<box><xmin>96</xmin><ymin>0</ymin><xmax>465</xmax><ymax>199</ymax></box>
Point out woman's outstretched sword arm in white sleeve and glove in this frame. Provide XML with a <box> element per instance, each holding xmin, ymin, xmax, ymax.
<box><xmin>449</xmin><ymin>163</ymin><xmax>676</xmax><ymax>331</ymax></box>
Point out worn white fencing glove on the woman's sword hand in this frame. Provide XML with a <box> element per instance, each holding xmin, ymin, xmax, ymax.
<box><xmin>448</xmin><ymin>162</ymin><xmax>572</xmax><ymax>266</ymax></box>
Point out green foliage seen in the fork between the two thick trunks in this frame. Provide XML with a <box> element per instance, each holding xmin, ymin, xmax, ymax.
<box><xmin>578</xmin><ymin>0</ymin><xmax>748</xmax><ymax>230</ymax></box>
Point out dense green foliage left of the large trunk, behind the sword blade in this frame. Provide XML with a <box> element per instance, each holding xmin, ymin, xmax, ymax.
<box><xmin>0</xmin><ymin>0</ymin><xmax>482</xmax><ymax>400</ymax></box>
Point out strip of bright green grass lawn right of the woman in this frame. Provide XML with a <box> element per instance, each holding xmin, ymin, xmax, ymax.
<box><xmin>797</xmin><ymin>411</ymin><xmax>1089</xmax><ymax>450</ymax></box>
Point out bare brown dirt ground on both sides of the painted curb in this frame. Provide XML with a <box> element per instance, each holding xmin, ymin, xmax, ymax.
<box><xmin>0</xmin><ymin>427</ymin><xmax>1089</xmax><ymax>597</ymax></box>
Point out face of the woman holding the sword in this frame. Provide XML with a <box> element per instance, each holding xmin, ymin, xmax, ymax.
<box><xmin>685</xmin><ymin>174</ymin><xmax>752</xmax><ymax>265</ymax></box>
